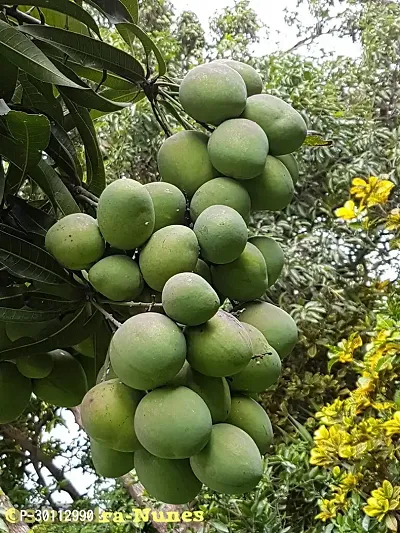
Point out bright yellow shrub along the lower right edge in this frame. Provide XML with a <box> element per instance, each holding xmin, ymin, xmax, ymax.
<box><xmin>310</xmin><ymin>304</ymin><xmax>400</xmax><ymax>531</ymax></box>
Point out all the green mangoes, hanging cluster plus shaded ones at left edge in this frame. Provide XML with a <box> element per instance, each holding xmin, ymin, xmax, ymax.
<box><xmin>0</xmin><ymin>61</ymin><xmax>306</xmax><ymax>504</ymax></box>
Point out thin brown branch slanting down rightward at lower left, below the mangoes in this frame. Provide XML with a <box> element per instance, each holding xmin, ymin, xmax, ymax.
<box><xmin>1</xmin><ymin>424</ymin><xmax>82</xmax><ymax>501</ymax></box>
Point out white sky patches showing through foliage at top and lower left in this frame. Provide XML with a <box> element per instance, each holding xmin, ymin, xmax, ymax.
<box><xmin>32</xmin><ymin>0</ymin><xmax>366</xmax><ymax>504</ymax></box>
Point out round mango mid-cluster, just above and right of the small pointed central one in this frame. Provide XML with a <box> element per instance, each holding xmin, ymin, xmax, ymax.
<box><xmin>193</xmin><ymin>205</ymin><xmax>247</xmax><ymax>265</ymax></box>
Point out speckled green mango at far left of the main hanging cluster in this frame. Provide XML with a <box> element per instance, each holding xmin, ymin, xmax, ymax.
<box><xmin>46</xmin><ymin>213</ymin><xmax>105</xmax><ymax>270</ymax></box>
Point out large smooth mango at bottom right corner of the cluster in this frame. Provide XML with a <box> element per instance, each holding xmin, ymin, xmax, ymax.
<box><xmin>190</xmin><ymin>424</ymin><xmax>263</xmax><ymax>494</ymax></box>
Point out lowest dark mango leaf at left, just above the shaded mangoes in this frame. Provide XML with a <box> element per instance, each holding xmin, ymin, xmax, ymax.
<box><xmin>0</xmin><ymin>305</ymin><xmax>101</xmax><ymax>361</ymax></box>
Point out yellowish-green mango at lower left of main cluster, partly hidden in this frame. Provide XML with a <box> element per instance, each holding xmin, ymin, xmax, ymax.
<box><xmin>81</xmin><ymin>379</ymin><xmax>143</xmax><ymax>452</ymax></box>
